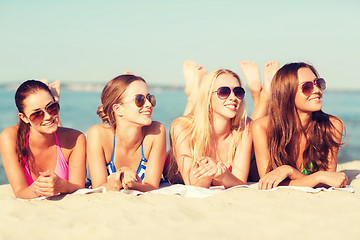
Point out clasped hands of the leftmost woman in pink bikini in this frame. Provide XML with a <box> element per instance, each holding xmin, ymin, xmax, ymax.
<box><xmin>34</xmin><ymin>170</ymin><xmax>64</xmax><ymax>196</ymax></box>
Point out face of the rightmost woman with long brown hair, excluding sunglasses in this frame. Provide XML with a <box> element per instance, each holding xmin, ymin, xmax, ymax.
<box><xmin>295</xmin><ymin>68</ymin><xmax>323</xmax><ymax>113</ymax></box>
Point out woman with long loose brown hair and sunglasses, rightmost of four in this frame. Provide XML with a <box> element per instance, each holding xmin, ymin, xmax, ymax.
<box><xmin>252</xmin><ymin>63</ymin><xmax>347</xmax><ymax>189</ymax></box>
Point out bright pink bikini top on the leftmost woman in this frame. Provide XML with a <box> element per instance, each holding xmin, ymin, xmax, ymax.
<box><xmin>23</xmin><ymin>132</ymin><xmax>69</xmax><ymax>186</ymax></box>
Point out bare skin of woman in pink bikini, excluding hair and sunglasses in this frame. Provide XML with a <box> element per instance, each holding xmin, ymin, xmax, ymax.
<box><xmin>0</xmin><ymin>90</ymin><xmax>86</xmax><ymax>198</ymax></box>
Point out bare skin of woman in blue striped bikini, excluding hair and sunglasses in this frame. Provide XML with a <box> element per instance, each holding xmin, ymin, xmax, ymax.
<box><xmin>87</xmin><ymin>81</ymin><xmax>166</xmax><ymax>191</ymax></box>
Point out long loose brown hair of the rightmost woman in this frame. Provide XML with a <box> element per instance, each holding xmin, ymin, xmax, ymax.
<box><xmin>268</xmin><ymin>62</ymin><xmax>345</xmax><ymax>172</ymax></box>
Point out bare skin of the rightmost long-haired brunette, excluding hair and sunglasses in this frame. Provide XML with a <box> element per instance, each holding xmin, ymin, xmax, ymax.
<box><xmin>252</xmin><ymin>68</ymin><xmax>347</xmax><ymax>189</ymax></box>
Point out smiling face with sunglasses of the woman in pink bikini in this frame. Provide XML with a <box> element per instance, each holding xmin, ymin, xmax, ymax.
<box><xmin>19</xmin><ymin>90</ymin><xmax>58</xmax><ymax>133</ymax></box>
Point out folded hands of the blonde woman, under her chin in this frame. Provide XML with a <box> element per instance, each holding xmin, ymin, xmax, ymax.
<box><xmin>193</xmin><ymin>157</ymin><xmax>229</xmax><ymax>181</ymax></box>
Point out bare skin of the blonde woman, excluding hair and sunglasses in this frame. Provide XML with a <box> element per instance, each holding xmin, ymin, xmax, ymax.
<box><xmin>172</xmin><ymin>74</ymin><xmax>252</xmax><ymax>188</ymax></box>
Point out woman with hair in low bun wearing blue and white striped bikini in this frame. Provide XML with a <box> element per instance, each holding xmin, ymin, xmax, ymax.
<box><xmin>87</xmin><ymin>74</ymin><xmax>166</xmax><ymax>191</ymax></box>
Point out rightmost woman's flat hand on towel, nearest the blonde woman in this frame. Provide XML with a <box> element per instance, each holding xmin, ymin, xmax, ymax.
<box><xmin>258</xmin><ymin>165</ymin><xmax>293</xmax><ymax>190</ymax></box>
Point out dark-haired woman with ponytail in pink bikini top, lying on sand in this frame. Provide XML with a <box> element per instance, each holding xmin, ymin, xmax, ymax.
<box><xmin>0</xmin><ymin>80</ymin><xmax>86</xmax><ymax>198</ymax></box>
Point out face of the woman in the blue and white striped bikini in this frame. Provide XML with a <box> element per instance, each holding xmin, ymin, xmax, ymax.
<box><xmin>118</xmin><ymin>81</ymin><xmax>153</xmax><ymax>126</ymax></box>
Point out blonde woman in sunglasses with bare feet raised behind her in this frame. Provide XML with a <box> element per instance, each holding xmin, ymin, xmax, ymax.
<box><xmin>167</xmin><ymin>61</ymin><xmax>278</xmax><ymax>188</ymax></box>
